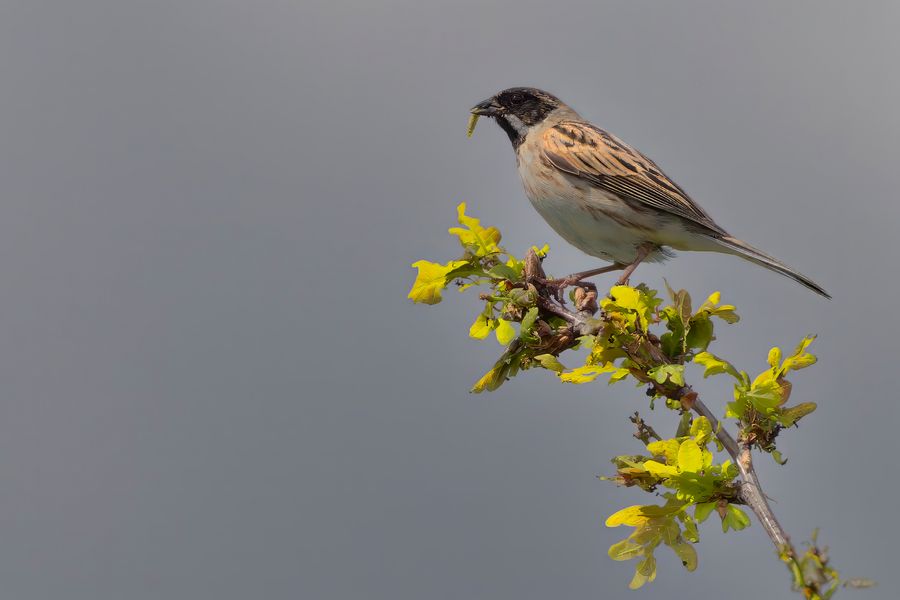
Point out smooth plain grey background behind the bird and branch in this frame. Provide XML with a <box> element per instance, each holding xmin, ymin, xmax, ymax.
<box><xmin>0</xmin><ymin>0</ymin><xmax>900</xmax><ymax>600</ymax></box>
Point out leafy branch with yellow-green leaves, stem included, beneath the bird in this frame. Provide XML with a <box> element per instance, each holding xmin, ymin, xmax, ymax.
<box><xmin>409</xmin><ymin>204</ymin><xmax>868</xmax><ymax>600</ymax></box>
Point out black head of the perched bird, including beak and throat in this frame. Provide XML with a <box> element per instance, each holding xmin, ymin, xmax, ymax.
<box><xmin>471</xmin><ymin>87</ymin><xmax>563</xmax><ymax>146</ymax></box>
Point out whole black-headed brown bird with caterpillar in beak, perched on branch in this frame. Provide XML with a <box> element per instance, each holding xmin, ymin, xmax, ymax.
<box><xmin>470</xmin><ymin>87</ymin><xmax>831</xmax><ymax>300</ymax></box>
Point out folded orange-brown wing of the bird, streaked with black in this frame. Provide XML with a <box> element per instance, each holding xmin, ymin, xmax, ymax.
<box><xmin>541</xmin><ymin>121</ymin><xmax>726</xmax><ymax>235</ymax></box>
